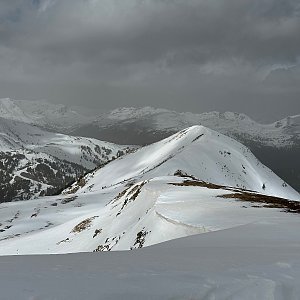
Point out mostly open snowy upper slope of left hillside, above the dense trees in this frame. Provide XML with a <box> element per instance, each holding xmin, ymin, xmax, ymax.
<box><xmin>0</xmin><ymin>118</ymin><xmax>130</xmax><ymax>169</ymax></box>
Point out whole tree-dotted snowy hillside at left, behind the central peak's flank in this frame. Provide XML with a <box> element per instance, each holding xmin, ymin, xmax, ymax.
<box><xmin>0</xmin><ymin>118</ymin><xmax>128</xmax><ymax>202</ymax></box>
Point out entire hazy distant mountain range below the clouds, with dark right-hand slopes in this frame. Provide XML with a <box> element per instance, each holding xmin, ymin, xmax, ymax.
<box><xmin>0</xmin><ymin>99</ymin><xmax>300</xmax><ymax>191</ymax></box>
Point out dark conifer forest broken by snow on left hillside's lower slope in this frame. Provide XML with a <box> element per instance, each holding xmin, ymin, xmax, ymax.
<box><xmin>0</xmin><ymin>149</ymin><xmax>86</xmax><ymax>202</ymax></box>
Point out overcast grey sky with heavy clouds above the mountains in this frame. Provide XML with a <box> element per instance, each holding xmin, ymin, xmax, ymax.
<box><xmin>0</xmin><ymin>0</ymin><xmax>300</xmax><ymax>120</ymax></box>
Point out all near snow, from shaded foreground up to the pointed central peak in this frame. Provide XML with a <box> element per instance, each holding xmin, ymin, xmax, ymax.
<box><xmin>0</xmin><ymin>126</ymin><xmax>300</xmax><ymax>299</ymax></box>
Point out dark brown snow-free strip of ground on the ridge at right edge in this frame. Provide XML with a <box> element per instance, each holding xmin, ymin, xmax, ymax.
<box><xmin>218</xmin><ymin>192</ymin><xmax>300</xmax><ymax>214</ymax></box>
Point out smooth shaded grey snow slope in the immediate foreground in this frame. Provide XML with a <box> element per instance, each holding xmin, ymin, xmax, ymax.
<box><xmin>0</xmin><ymin>215</ymin><xmax>300</xmax><ymax>300</ymax></box>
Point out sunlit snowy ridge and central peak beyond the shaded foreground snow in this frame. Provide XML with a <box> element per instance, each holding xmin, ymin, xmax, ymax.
<box><xmin>0</xmin><ymin>126</ymin><xmax>300</xmax><ymax>255</ymax></box>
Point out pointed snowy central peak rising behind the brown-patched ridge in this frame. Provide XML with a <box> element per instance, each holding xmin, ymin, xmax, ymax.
<box><xmin>68</xmin><ymin>125</ymin><xmax>299</xmax><ymax>200</ymax></box>
